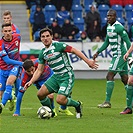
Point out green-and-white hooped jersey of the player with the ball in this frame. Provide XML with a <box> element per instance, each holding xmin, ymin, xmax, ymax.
<box><xmin>39</xmin><ymin>41</ymin><xmax>72</xmax><ymax>74</ymax></box>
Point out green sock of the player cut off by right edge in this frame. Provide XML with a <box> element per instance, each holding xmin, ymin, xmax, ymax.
<box><xmin>126</xmin><ymin>85</ymin><xmax>133</xmax><ymax>109</ymax></box>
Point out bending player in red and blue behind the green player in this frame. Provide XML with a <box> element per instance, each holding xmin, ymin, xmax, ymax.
<box><xmin>13</xmin><ymin>59</ymin><xmax>73</xmax><ymax>116</ymax></box>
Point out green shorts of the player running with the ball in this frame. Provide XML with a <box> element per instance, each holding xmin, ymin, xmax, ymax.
<box><xmin>44</xmin><ymin>71</ymin><xmax>75</xmax><ymax>97</ymax></box>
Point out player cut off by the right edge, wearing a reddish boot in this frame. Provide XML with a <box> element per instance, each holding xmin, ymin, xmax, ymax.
<box><xmin>120</xmin><ymin>44</ymin><xmax>133</xmax><ymax>114</ymax></box>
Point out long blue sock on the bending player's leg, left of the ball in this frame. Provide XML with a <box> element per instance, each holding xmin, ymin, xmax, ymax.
<box><xmin>14</xmin><ymin>91</ymin><xmax>24</xmax><ymax>115</ymax></box>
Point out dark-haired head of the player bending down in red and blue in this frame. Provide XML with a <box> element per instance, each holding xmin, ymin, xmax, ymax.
<box><xmin>23</xmin><ymin>59</ymin><xmax>35</xmax><ymax>76</ymax></box>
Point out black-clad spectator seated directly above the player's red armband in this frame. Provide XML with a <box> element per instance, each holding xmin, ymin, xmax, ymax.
<box><xmin>62</xmin><ymin>19</ymin><xmax>79</xmax><ymax>40</ymax></box>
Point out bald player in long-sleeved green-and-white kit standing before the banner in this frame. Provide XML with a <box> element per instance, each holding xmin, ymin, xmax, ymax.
<box><xmin>93</xmin><ymin>9</ymin><xmax>131</xmax><ymax>108</ymax></box>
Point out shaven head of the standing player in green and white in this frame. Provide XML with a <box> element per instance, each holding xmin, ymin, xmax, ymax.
<box><xmin>107</xmin><ymin>9</ymin><xmax>116</xmax><ymax>24</ymax></box>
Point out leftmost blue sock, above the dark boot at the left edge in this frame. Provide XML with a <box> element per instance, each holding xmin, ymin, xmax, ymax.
<box><xmin>2</xmin><ymin>85</ymin><xmax>12</xmax><ymax>106</ymax></box>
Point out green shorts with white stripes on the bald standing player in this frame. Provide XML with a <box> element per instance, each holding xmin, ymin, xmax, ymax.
<box><xmin>109</xmin><ymin>57</ymin><xmax>128</xmax><ymax>75</ymax></box>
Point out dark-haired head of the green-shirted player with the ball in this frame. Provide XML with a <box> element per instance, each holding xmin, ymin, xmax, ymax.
<box><xmin>40</xmin><ymin>28</ymin><xmax>53</xmax><ymax>47</ymax></box>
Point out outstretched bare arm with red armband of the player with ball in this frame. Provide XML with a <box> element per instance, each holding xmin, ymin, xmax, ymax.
<box><xmin>66</xmin><ymin>46</ymin><xmax>98</xmax><ymax>69</ymax></box>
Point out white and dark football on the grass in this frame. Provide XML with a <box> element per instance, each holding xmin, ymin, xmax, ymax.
<box><xmin>37</xmin><ymin>106</ymin><xmax>52</xmax><ymax>119</ymax></box>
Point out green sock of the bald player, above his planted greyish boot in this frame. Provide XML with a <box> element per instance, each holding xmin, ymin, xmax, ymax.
<box><xmin>105</xmin><ymin>81</ymin><xmax>114</xmax><ymax>102</ymax></box>
